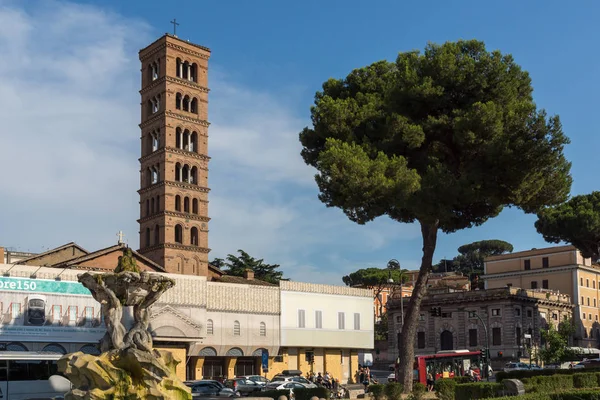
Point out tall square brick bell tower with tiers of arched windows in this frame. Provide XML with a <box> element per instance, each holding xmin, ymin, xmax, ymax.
<box><xmin>138</xmin><ymin>34</ymin><xmax>210</xmax><ymax>276</ymax></box>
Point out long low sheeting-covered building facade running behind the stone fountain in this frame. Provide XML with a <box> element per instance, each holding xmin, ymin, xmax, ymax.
<box><xmin>0</xmin><ymin>264</ymin><xmax>373</xmax><ymax>382</ymax></box>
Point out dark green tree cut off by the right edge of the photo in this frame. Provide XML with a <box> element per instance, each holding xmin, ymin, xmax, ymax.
<box><xmin>535</xmin><ymin>192</ymin><xmax>600</xmax><ymax>262</ymax></box>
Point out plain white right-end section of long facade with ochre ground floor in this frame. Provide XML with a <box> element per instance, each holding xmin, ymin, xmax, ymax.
<box><xmin>272</xmin><ymin>281</ymin><xmax>374</xmax><ymax>382</ymax></box>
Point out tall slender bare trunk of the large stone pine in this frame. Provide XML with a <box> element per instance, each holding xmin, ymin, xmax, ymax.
<box><xmin>398</xmin><ymin>221</ymin><xmax>439</xmax><ymax>393</ymax></box>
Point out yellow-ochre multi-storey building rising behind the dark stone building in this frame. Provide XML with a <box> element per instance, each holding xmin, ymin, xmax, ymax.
<box><xmin>483</xmin><ymin>245</ymin><xmax>600</xmax><ymax>347</ymax></box>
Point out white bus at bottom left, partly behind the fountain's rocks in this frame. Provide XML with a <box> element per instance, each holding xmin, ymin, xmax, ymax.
<box><xmin>0</xmin><ymin>351</ymin><xmax>71</xmax><ymax>400</ymax></box>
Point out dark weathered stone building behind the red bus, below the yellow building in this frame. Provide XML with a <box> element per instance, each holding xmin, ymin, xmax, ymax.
<box><xmin>388</xmin><ymin>288</ymin><xmax>573</xmax><ymax>361</ymax></box>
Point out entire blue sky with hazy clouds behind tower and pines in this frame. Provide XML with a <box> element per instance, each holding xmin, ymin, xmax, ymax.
<box><xmin>0</xmin><ymin>0</ymin><xmax>600</xmax><ymax>284</ymax></box>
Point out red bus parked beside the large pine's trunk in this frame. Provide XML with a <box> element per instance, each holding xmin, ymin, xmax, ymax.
<box><xmin>396</xmin><ymin>350</ymin><xmax>483</xmax><ymax>385</ymax></box>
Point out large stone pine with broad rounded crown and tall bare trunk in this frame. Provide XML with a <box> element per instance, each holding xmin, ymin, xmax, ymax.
<box><xmin>300</xmin><ymin>40</ymin><xmax>571</xmax><ymax>392</ymax></box>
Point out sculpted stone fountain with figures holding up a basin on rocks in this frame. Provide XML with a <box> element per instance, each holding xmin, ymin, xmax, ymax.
<box><xmin>58</xmin><ymin>249</ymin><xmax>192</xmax><ymax>400</ymax></box>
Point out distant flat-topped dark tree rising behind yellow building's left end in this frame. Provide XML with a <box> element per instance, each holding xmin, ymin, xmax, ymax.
<box><xmin>453</xmin><ymin>240</ymin><xmax>513</xmax><ymax>277</ymax></box>
